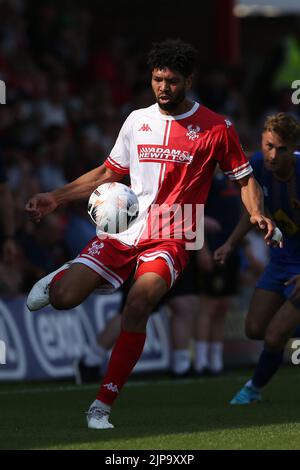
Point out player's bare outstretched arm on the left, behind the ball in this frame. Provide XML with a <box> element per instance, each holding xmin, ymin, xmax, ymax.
<box><xmin>25</xmin><ymin>165</ymin><xmax>123</xmax><ymax>222</ymax></box>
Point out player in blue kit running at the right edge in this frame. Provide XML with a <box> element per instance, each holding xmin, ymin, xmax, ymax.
<box><xmin>214</xmin><ymin>113</ymin><xmax>300</xmax><ymax>404</ymax></box>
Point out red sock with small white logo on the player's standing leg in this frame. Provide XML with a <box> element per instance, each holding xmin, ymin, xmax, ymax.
<box><xmin>97</xmin><ymin>330</ymin><xmax>146</xmax><ymax>405</ymax></box>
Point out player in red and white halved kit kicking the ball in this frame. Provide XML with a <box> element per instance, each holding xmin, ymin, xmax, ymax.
<box><xmin>26</xmin><ymin>39</ymin><xmax>275</xmax><ymax>429</ymax></box>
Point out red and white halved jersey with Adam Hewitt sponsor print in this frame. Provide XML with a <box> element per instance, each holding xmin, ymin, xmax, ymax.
<box><xmin>105</xmin><ymin>102</ymin><xmax>252</xmax><ymax>245</ymax></box>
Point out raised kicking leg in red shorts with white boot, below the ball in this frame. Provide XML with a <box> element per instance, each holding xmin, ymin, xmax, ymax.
<box><xmin>27</xmin><ymin>237</ymin><xmax>135</xmax><ymax>310</ymax></box>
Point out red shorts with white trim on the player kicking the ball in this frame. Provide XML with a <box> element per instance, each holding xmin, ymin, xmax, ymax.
<box><xmin>73</xmin><ymin>237</ymin><xmax>189</xmax><ymax>293</ymax></box>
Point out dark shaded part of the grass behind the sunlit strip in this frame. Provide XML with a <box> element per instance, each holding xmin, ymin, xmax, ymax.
<box><xmin>0</xmin><ymin>368</ymin><xmax>300</xmax><ymax>450</ymax></box>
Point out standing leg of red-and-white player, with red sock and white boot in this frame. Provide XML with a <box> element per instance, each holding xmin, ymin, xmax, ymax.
<box><xmin>87</xmin><ymin>261</ymin><xmax>169</xmax><ymax>429</ymax></box>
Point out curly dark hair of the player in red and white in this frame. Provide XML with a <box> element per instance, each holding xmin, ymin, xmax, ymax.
<box><xmin>147</xmin><ymin>38</ymin><xmax>198</xmax><ymax>77</ymax></box>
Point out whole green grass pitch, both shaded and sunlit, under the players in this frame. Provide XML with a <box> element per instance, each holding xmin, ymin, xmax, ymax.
<box><xmin>0</xmin><ymin>367</ymin><xmax>300</xmax><ymax>450</ymax></box>
